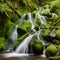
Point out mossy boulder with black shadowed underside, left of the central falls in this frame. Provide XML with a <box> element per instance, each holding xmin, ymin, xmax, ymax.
<box><xmin>17</xmin><ymin>21</ymin><xmax>32</xmax><ymax>35</ymax></box>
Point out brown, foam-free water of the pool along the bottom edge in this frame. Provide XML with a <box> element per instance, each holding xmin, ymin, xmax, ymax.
<box><xmin>0</xmin><ymin>56</ymin><xmax>48</xmax><ymax>60</ymax></box>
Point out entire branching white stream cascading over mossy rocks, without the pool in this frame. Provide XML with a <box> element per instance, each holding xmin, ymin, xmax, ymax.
<box><xmin>4</xmin><ymin>12</ymin><xmax>47</xmax><ymax>57</ymax></box>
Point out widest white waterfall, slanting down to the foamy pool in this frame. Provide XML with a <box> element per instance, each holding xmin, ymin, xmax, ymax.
<box><xmin>15</xmin><ymin>34</ymin><xmax>34</xmax><ymax>53</ymax></box>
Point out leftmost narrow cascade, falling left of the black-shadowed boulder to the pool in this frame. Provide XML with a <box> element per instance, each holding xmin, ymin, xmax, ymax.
<box><xmin>5</xmin><ymin>25</ymin><xmax>18</xmax><ymax>52</ymax></box>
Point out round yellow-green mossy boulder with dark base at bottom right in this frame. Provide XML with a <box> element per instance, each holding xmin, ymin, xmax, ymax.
<box><xmin>45</xmin><ymin>45</ymin><xmax>57</xmax><ymax>57</ymax></box>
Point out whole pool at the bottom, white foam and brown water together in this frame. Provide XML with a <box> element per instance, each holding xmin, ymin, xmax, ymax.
<box><xmin>0</xmin><ymin>53</ymin><xmax>48</xmax><ymax>60</ymax></box>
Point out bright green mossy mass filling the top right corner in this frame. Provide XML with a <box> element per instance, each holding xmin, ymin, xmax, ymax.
<box><xmin>51</xmin><ymin>0</ymin><xmax>60</xmax><ymax>17</ymax></box>
